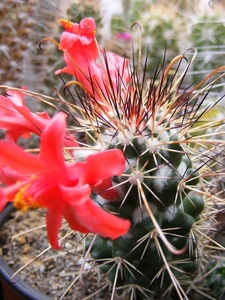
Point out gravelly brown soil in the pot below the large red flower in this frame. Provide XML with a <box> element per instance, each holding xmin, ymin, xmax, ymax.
<box><xmin>0</xmin><ymin>210</ymin><xmax>111</xmax><ymax>300</ymax></box>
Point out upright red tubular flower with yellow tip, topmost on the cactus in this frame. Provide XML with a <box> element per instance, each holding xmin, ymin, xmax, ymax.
<box><xmin>55</xmin><ymin>18</ymin><xmax>104</xmax><ymax>94</ymax></box>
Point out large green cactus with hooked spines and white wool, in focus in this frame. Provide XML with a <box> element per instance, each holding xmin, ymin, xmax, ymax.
<box><xmin>68</xmin><ymin>52</ymin><xmax>224</xmax><ymax>299</ymax></box>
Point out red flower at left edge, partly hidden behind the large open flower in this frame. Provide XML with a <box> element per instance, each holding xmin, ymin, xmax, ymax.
<box><xmin>0</xmin><ymin>90</ymin><xmax>78</xmax><ymax>147</ymax></box>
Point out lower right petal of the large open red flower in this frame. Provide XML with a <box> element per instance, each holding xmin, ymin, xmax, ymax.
<box><xmin>60</xmin><ymin>185</ymin><xmax>130</xmax><ymax>239</ymax></box>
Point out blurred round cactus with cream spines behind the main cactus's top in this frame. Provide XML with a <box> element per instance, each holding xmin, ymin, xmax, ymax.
<box><xmin>111</xmin><ymin>0</ymin><xmax>187</xmax><ymax>71</ymax></box>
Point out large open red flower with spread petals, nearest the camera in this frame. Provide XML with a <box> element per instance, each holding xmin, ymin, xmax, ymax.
<box><xmin>0</xmin><ymin>113</ymin><xmax>130</xmax><ymax>249</ymax></box>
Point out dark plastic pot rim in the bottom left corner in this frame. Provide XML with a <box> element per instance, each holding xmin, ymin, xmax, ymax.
<box><xmin>0</xmin><ymin>204</ymin><xmax>50</xmax><ymax>300</ymax></box>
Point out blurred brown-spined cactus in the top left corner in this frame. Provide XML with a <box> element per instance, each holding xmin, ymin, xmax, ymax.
<box><xmin>0</xmin><ymin>0</ymin><xmax>38</xmax><ymax>87</ymax></box>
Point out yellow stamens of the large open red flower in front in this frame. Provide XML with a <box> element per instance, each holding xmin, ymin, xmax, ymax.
<box><xmin>13</xmin><ymin>184</ymin><xmax>40</xmax><ymax>212</ymax></box>
